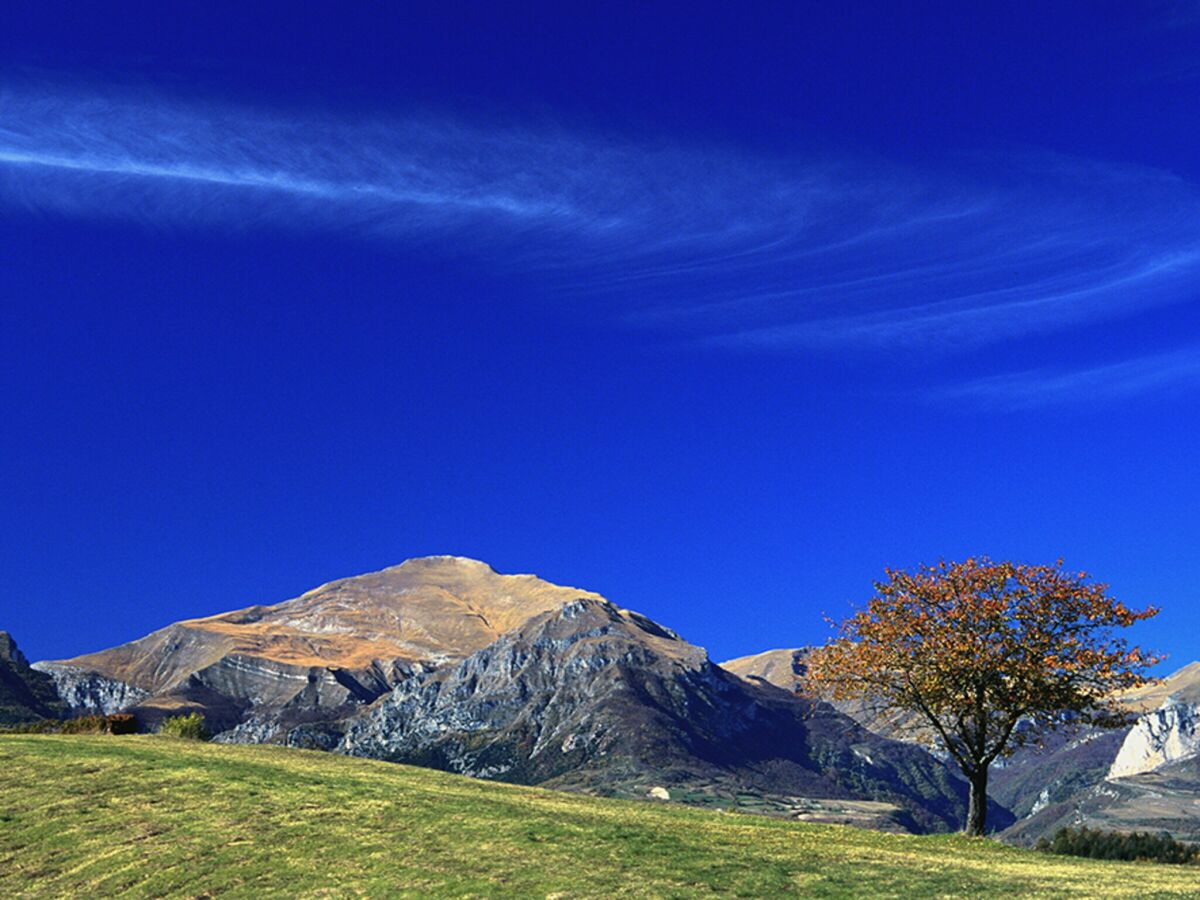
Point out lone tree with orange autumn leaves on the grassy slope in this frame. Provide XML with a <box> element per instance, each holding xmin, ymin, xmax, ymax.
<box><xmin>806</xmin><ymin>557</ymin><xmax>1159</xmax><ymax>835</ymax></box>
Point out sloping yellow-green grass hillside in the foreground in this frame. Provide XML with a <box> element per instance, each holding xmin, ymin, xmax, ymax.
<box><xmin>0</xmin><ymin>734</ymin><xmax>1200</xmax><ymax>898</ymax></box>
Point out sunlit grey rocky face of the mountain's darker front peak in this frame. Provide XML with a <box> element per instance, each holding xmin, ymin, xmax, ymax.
<box><xmin>338</xmin><ymin>600</ymin><xmax>712</xmax><ymax>781</ymax></box>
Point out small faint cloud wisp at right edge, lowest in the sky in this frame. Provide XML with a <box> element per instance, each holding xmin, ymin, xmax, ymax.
<box><xmin>932</xmin><ymin>346</ymin><xmax>1200</xmax><ymax>410</ymax></box>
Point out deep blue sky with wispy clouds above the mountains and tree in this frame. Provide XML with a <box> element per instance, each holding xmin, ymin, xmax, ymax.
<box><xmin>0</xmin><ymin>2</ymin><xmax>1200</xmax><ymax>667</ymax></box>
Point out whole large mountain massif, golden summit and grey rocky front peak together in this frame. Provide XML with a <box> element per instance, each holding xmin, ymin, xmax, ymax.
<box><xmin>38</xmin><ymin>557</ymin><xmax>1003</xmax><ymax>830</ymax></box>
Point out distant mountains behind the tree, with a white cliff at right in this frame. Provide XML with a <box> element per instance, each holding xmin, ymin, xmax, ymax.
<box><xmin>721</xmin><ymin>649</ymin><xmax>1200</xmax><ymax>844</ymax></box>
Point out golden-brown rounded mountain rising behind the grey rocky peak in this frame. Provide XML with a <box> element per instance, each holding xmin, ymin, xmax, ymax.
<box><xmin>37</xmin><ymin>557</ymin><xmax>599</xmax><ymax>731</ymax></box>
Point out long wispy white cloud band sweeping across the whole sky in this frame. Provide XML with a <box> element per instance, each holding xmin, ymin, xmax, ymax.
<box><xmin>7</xmin><ymin>85</ymin><xmax>1200</xmax><ymax>353</ymax></box>
